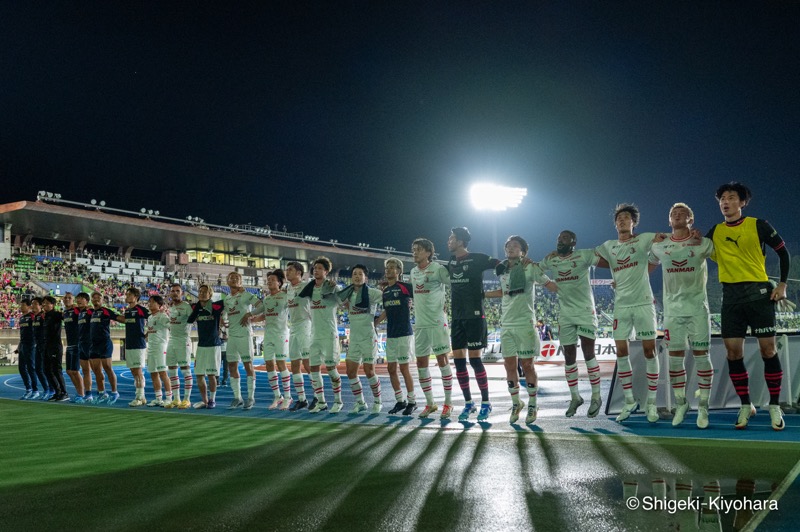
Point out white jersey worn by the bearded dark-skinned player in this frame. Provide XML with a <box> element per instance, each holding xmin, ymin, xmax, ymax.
<box><xmin>540</xmin><ymin>249</ymin><xmax>599</xmax><ymax>318</ymax></box>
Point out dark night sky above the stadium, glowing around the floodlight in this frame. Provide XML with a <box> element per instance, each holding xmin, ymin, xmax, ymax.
<box><xmin>0</xmin><ymin>1</ymin><xmax>800</xmax><ymax>259</ymax></box>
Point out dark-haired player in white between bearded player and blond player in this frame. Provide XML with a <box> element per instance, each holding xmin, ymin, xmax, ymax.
<box><xmin>595</xmin><ymin>203</ymin><xmax>659</xmax><ymax>423</ymax></box>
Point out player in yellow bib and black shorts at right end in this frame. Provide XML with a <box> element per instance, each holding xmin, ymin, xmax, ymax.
<box><xmin>706</xmin><ymin>182</ymin><xmax>791</xmax><ymax>430</ymax></box>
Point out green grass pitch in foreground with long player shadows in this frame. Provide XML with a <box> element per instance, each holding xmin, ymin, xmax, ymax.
<box><xmin>0</xmin><ymin>400</ymin><xmax>798</xmax><ymax>531</ymax></box>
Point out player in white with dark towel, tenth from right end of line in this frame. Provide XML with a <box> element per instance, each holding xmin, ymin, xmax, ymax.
<box><xmin>298</xmin><ymin>257</ymin><xmax>344</xmax><ymax>414</ymax></box>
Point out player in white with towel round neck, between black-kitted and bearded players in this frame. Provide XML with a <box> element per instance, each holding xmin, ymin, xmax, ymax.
<box><xmin>485</xmin><ymin>235</ymin><xmax>557</xmax><ymax>424</ymax></box>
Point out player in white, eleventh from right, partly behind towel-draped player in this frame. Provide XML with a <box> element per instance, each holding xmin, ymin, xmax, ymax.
<box><xmin>286</xmin><ymin>262</ymin><xmax>311</xmax><ymax>412</ymax></box>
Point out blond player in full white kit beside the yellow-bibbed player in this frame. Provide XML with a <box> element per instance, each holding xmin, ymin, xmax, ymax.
<box><xmin>650</xmin><ymin>203</ymin><xmax>714</xmax><ymax>429</ymax></box>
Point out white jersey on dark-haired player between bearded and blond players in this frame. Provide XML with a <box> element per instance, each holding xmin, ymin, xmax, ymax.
<box><xmin>595</xmin><ymin>233</ymin><xmax>655</xmax><ymax>309</ymax></box>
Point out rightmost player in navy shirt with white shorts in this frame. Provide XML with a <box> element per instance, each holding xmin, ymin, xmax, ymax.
<box><xmin>376</xmin><ymin>257</ymin><xmax>417</xmax><ymax>416</ymax></box>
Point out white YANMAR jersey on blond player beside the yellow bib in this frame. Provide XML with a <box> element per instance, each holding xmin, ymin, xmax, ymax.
<box><xmin>650</xmin><ymin>237</ymin><xmax>714</xmax><ymax>317</ymax></box>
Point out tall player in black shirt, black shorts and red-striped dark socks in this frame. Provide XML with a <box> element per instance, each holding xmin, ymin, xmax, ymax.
<box><xmin>442</xmin><ymin>227</ymin><xmax>500</xmax><ymax>421</ymax></box>
